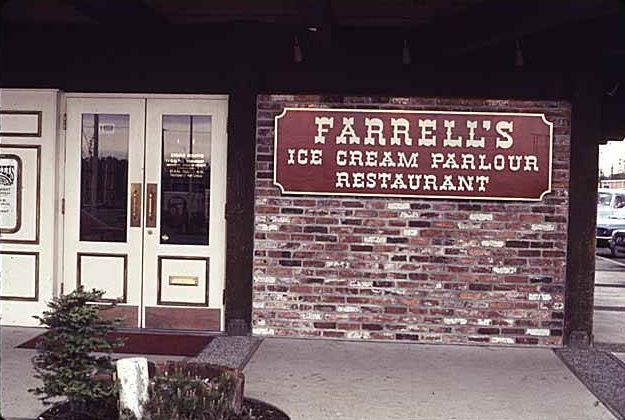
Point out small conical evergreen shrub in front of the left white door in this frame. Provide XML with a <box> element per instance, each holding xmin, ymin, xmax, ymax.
<box><xmin>29</xmin><ymin>288</ymin><xmax>121</xmax><ymax>419</ymax></box>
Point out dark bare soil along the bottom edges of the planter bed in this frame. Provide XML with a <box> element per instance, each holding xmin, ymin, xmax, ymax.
<box><xmin>37</xmin><ymin>398</ymin><xmax>291</xmax><ymax>420</ymax></box>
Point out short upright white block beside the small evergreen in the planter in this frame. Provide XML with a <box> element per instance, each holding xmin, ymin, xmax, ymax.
<box><xmin>117</xmin><ymin>357</ymin><xmax>150</xmax><ymax>419</ymax></box>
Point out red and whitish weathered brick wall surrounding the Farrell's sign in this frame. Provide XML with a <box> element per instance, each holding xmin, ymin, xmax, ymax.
<box><xmin>253</xmin><ymin>95</ymin><xmax>570</xmax><ymax>346</ymax></box>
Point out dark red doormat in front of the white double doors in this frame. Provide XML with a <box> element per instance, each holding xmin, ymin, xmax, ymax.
<box><xmin>17</xmin><ymin>331</ymin><xmax>215</xmax><ymax>357</ymax></box>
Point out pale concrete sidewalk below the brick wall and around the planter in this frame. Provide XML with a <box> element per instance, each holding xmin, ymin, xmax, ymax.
<box><xmin>0</xmin><ymin>327</ymin><xmax>614</xmax><ymax>420</ymax></box>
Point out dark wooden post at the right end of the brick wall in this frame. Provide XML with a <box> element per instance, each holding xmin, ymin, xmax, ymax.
<box><xmin>564</xmin><ymin>72</ymin><xmax>601</xmax><ymax>347</ymax></box>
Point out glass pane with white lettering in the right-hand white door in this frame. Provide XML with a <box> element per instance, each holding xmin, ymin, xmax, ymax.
<box><xmin>161</xmin><ymin>115</ymin><xmax>211</xmax><ymax>245</ymax></box>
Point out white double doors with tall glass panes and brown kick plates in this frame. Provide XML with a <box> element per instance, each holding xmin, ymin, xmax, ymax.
<box><xmin>63</xmin><ymin>95</ymin><xmax>227</xmax><ymax>330</ymax></box>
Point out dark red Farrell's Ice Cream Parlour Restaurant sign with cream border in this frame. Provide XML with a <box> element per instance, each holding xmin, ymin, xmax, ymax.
<box><xmin>274</xmin><ymin>108</ymin><xmax>553</xmax><ymax>200</ymax></box>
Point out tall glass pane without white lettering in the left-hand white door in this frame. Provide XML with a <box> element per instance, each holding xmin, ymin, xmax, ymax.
<box><xmin>80</xmin><ymin>114</ymin><xmax>130</xmax><ymax>242</ymax></box>
